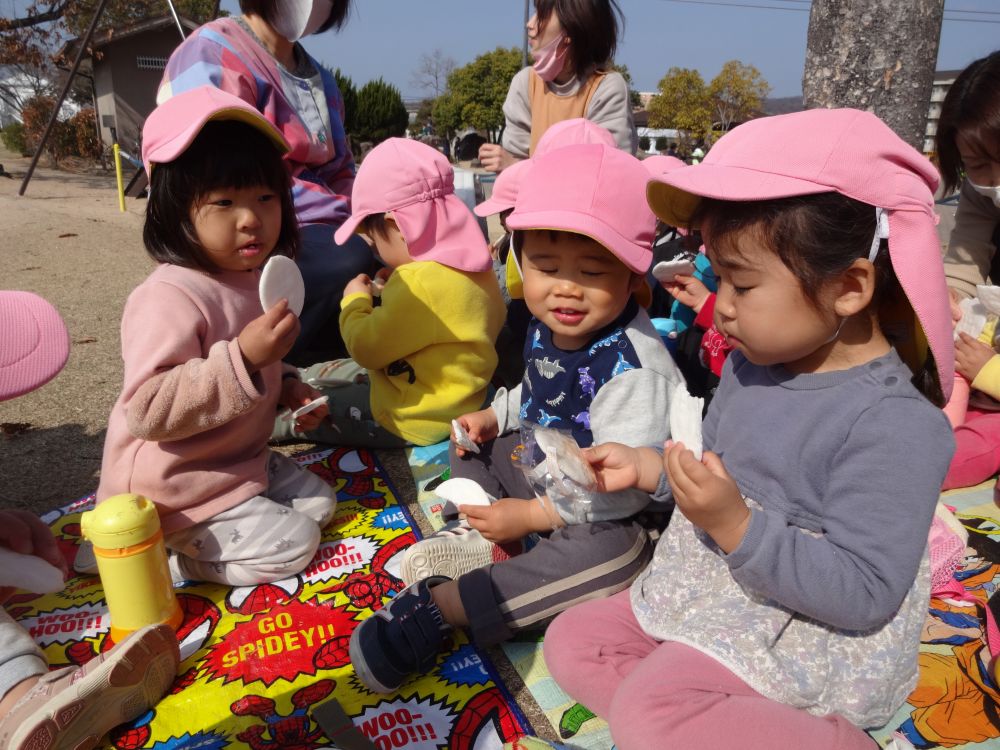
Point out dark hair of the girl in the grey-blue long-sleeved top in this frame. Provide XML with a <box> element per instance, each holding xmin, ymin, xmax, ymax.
<box><xmin>690</xmin><ymin>192</ymin><xmax>944</xmax><ymax>406</ymax></box>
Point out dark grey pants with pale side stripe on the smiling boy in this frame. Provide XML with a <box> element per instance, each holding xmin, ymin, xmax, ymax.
<box><xmin>450</xmin><ymin>432</ymin><xmax>653</xmax><ymax>646</ymax></box>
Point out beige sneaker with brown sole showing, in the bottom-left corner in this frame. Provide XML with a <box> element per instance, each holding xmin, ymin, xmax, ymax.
<box><xmin>0</xmin><ymin>625</ymin><xmax>180</xmax><ymax>750</ymax></box>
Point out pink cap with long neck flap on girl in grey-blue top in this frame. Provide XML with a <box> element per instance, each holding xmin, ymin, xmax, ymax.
<box><xmin>646</xmin><ymin>109</ymin><xmax>955</xmax><ymax>398</ymax></box>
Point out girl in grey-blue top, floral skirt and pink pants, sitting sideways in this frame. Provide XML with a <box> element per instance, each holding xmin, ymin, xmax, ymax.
<box><xmin>545</xmin><ymin>110</ymin><xmax>954</xmax><ymax>750</ymax></box>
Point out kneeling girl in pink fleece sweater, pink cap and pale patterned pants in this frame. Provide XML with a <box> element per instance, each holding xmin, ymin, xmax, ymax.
<box><xmin>96</xmin><ymin>86</ymin><xmax>336</xmax><ymax>586</ymax></box>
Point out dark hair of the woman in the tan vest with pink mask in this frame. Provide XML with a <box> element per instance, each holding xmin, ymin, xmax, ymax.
<box><xmin>535</xmin><ymin>0</ymin><xmax>625</xmax><ymax>79</ymax></box>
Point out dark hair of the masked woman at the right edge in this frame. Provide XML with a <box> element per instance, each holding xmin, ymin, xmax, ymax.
<box><xmin>935</xmin><ymin>51</ymin><xmax>1000</xmax><ymax>193</ymax></box>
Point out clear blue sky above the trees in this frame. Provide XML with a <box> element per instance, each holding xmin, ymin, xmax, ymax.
<box><xmin>207</xmin><ymin>0</ymin><xmax>1000</xmax><ymax>98</ymax></box>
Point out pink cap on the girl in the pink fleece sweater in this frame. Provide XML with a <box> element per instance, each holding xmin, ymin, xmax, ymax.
<box><xmin>142</xmin><ymin>86</ymin><xmax>288</xmax><ymax>174</ymax></box>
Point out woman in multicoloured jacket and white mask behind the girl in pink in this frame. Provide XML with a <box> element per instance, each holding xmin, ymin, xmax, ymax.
<box><xmin>157</xmin><ymin>0</ymin><xmax>374</xmax><ymax>365</ymax></box>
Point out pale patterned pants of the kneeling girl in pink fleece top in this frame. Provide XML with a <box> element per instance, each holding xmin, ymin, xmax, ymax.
<box><xmin>164</xmin><ymin>453</ymin><xmax>337</xmax><ymax>586</ymax></box>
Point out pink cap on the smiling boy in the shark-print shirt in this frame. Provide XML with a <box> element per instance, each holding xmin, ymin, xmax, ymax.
<box><xmin>507</xmin><ymin>144</ymin><xmax>656</xmax><ymax>273</ymax></box>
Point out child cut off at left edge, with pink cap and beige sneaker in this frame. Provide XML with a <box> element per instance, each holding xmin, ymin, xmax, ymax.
<box><xmin>0</xmin><ymin>291</ymin><xmax>180</xmax><ymax>750</ymax></box>
